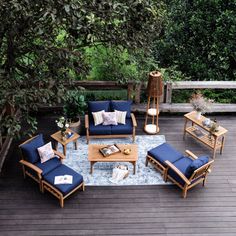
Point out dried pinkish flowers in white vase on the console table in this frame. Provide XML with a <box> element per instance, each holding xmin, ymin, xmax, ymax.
<box><xmin>190</xmin><ymin>91</ymin><xmax>213</xmax><ymax>120</ymax></box>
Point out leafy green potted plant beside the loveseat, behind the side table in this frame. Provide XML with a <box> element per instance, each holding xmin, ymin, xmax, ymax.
<box><xmin>63</xmin><ymin>91</ymin><xmax>86</xmax><ymax>133</ymax></box>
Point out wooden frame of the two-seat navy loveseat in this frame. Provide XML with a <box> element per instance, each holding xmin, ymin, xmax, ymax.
<box><xmin>85</xmin><ymin>113</ymin><xmax>137</xmax><ymax>144</ymax></box>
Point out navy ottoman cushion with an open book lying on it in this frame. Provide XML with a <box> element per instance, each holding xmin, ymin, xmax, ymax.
<box><xmin>43</xmin><ymin>164</ymin><xmax>83</xmax><ymax>196</ymax></box>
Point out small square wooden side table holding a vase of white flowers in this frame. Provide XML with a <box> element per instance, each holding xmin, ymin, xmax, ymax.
<box><xmin>51</xmin><ymin>128</ymin><xmax>80</xmax><ymax>156</ymax></box>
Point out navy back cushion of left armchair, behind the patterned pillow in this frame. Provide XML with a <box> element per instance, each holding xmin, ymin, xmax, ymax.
<box><xmin>20</xmin><ymin>134</ymin><xmax>44</xmax><ymax>163</ymax></box>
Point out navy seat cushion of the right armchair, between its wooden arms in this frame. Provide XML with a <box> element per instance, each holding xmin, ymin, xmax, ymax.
<box><xmin>168</xmin><ymin>157</ymin><xmax>193</xmax><ymax>186</ymax></box>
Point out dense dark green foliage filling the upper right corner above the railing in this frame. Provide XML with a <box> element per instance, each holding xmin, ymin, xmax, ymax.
<box><xmin>155</xmin><ymin>0</ymin><xmax>236</xmax><ymax>80</ymax></box>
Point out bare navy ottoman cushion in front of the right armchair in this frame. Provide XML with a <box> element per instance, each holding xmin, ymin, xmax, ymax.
<box><xmin>148</xmin><ymin>143</ymin><xmax>183</xmax><ymax>166</ymax></box>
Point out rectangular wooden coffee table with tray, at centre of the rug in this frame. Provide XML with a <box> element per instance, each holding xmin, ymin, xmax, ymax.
<box><xmin>88</xmin><ymin>144</ymin><xmax>138</xmax><ymax>174</ymax></box>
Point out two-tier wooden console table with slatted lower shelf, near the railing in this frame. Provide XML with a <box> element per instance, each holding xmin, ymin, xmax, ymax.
<box><xmin>183</xmin><ymin>111</ymin><xmax>228</xmax><ymax>159</ymax></box>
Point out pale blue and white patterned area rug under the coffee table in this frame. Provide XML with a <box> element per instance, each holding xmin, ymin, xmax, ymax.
<box><xmin>59</xmin><ymin>135</ymin><xmax>166</xmax><ymax>186</ymax></box>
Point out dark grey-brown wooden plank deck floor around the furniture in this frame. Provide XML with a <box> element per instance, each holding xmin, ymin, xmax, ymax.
<box><xmin>0</xmin><ymin>115</ymin><xmax>236</xmax><ymax>236</ymax></box>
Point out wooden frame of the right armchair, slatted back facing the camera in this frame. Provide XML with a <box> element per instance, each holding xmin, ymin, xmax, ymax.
<box><xmin>164</xmin><ymin>150</ymin><xmax>214</xmax><ymax>198</ymax></box>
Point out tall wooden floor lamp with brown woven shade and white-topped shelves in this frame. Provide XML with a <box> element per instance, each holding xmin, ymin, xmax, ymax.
<box><xmin>144</xmin><ymin>71</ymin><xmax>163</xmax><ymax>134</ymax></box>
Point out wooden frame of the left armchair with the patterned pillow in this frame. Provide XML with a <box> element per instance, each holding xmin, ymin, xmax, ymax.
<box><xmin>19</xmin><ymin>135</ymin><xmax>65</xmax><ymax>192</ymax></box>
